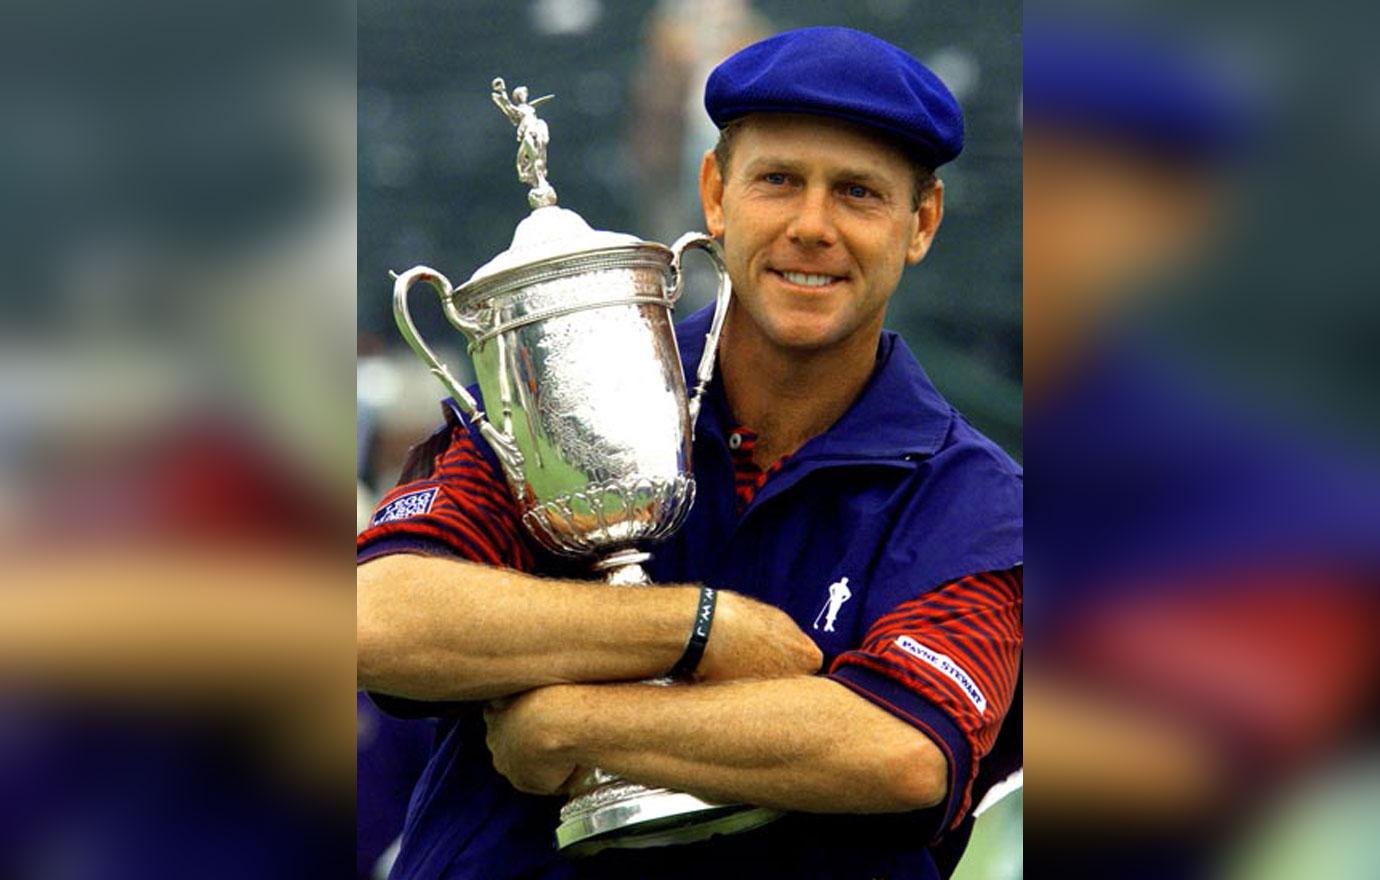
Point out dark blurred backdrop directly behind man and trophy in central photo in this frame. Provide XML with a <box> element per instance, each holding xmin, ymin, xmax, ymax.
<box><xmin>359</xmin><ymin>0</ymin><xmax>1021</xmax><ymax>518</ymax></box>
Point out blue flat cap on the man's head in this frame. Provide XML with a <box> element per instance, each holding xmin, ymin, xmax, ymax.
<box><xmin>704</xmin><ymin>28</ymin><xmax>963</xmax><ymax>168</ymax></box>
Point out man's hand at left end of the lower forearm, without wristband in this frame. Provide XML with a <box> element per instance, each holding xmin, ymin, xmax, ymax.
<box><xmin>484</xmin><ymin>684</ymin><xmax>580</xmax><ymax>794</ymax></box>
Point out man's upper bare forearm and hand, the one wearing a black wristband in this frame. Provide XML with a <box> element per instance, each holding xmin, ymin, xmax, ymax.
<box><xmin>356</xmin><ymin>553</ymin><xmax>821</xmax><ymax>701</ymax></box>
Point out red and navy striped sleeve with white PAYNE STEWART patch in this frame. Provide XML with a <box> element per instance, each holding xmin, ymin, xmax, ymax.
<box><xmin>828</xmin><ymin>567</ymin><xmax>1023</xmax><ymax>837</ymax></box>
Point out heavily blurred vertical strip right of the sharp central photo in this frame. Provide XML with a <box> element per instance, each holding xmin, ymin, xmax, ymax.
<box><xmin>1023</xmin><ymin>0</ymin><xmax>1380</xmax><ymax>880</ymax></box>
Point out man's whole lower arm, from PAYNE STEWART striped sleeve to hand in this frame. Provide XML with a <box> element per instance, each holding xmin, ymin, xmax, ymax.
<box><xmin>487</xmin><ymin>568</ymin><xmax>1021</xmax><ymax>830</ymax></box>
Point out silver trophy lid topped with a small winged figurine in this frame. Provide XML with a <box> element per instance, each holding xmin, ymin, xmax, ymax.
<box><xmin>465</xmin><ymin>79</ymin><xmax>644</xmax><ymax>287</ymax></box>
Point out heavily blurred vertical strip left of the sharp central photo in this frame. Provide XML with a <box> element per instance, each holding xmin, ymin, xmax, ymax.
<box><xmin>0</xmin><ymin>0</ymin><xmax>355</xmax><ymax>880</ymax></box>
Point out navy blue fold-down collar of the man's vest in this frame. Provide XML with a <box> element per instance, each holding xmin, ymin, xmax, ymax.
<box><xmin>676</xmin><ymin>305</ymin><xmax>955</xmax><ymax>462</ymax></box>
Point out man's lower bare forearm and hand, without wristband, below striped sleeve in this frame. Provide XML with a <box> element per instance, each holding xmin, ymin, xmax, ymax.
<box><xmin>486</xmin><ymin>676</ymin><xmax>948</xmax><ymax>812</ymax></box>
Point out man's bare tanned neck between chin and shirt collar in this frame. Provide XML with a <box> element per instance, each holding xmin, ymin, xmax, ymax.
<box><xmin>719</xmin><ymin>309</ymin><xmax>880</xmax><ymax>468</ymax></box>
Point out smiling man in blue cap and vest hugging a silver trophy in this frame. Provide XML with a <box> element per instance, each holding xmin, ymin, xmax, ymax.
<box><xmin>359</xmin><ymin>28</ymin><xmax>1021</xmax><ymax>877</ymax></box>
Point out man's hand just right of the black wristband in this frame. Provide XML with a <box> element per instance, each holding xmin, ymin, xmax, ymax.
<box><xmin>696</xmin><ymin>590</ymin><xmax>824</xmax><ymax>681</ymax></box>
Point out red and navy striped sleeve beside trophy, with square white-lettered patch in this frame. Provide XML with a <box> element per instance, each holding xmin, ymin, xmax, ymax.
<box><xmin>355</xmin><ymin>423</ymin><xmax>534</xmax><ymax>571</ymax></box>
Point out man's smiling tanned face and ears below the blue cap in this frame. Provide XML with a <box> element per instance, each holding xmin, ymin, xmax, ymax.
<box><xmin>700</xmin><ymin>113</ymin><xmax>944</xmax><ymax>350</ymax></box>
